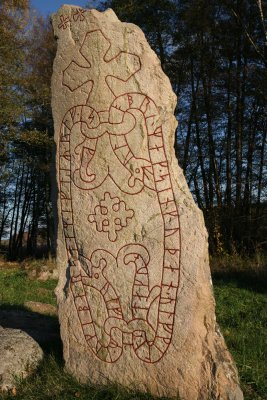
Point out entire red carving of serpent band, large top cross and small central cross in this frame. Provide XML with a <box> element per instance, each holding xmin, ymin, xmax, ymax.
<box><xmin>59</xmin><ymin>31</ymin><xmax>181</xmax><ymax>363</ymax></box>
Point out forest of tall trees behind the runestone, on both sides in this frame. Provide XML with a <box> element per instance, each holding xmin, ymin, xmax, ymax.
<box><xmin>0</xmin><ymin>0</ymin><xmax>267</xmax><ymax>260</ymax></box>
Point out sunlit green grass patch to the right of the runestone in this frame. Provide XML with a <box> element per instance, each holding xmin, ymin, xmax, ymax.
<box><xmin>214</xmin><ymin>279</ymin><xmax>267</xmax><ymax>400</ymax></box>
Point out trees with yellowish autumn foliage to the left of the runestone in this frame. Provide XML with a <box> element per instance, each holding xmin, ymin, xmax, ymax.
<box><xmin>0</xmin><ymin>0</ymin><xmax>55</xmax><ymax>258</ymax></box>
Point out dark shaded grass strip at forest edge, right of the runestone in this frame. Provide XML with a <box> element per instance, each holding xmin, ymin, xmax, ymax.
<box><xmin>212</xmin><ymin>269</ymin><xmax>267</xmax><ymax>293</ymax></box>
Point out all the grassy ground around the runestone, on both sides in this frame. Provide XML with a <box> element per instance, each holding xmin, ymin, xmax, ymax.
<box><xmin>0</xmin><ymin>268</ymin><xmax>267</xmax><ymax>400</ymax></box>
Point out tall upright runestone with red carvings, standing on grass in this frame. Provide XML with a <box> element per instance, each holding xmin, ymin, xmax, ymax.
<box><xmin>52</xmin><ymin>6</ymin><xmax>243</xmax><ymax>400</ymax></box>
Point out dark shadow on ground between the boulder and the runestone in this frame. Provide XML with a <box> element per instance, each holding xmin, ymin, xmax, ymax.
<box><xmin>0</xmin><ymin>304</ymin><xmax>62</xmax><ymax>359</ymax></box>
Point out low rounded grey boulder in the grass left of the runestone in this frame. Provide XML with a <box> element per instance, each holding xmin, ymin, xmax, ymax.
<box><xmin>0</xmin><ymin>326</ymin><xmax>43</xmax><ymax>392</ymax></box>
